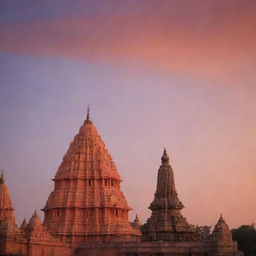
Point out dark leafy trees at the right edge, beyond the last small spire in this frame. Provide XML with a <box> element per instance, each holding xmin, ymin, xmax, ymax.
<box><xmin>231</xmin><ymin>224</ymin><xmax>256</xmax><ymax>256</ymax></box>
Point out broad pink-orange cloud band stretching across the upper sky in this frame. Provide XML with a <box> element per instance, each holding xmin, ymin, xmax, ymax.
<box><xmin>0</xmin><ymin>5</ymin><xmax>256</xmax><ymax>80</ymax></box>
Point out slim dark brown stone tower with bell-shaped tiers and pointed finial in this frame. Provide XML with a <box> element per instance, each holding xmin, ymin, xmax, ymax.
<box><xmin>142</xmin><ymin>149</ymin><xmax>196</xmax><ymax>241</ymax></box>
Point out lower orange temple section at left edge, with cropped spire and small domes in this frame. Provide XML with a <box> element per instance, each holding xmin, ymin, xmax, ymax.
<box><xmin>0</xmin><ymin>172</ymin><xmax>72</xmax><ymax>256</ymax></box>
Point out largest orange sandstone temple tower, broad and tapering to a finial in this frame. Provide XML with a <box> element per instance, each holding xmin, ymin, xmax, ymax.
<box><xmin>43</xmin><ymin>111</ymin><xmax>141</xmax><ymax>247</ymax></box>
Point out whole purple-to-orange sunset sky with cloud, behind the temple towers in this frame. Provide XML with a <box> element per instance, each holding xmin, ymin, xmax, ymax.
<box><xmin>0</xmin><ymin>0</ymin><xmax>256</xmax><ymax>228</ymax></box>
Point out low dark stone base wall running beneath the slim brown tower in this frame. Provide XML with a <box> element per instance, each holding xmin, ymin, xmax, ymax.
<box><xmin>75</xmin><ymin>241</ymin><xmax>243</xmax><ymax>256</ymax></box>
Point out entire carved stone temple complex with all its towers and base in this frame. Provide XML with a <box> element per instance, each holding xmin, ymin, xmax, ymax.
<box><xmin>0</xmin><ymin>109</ymin><xmax>242</xmax><ymax>256</ymax></box>
